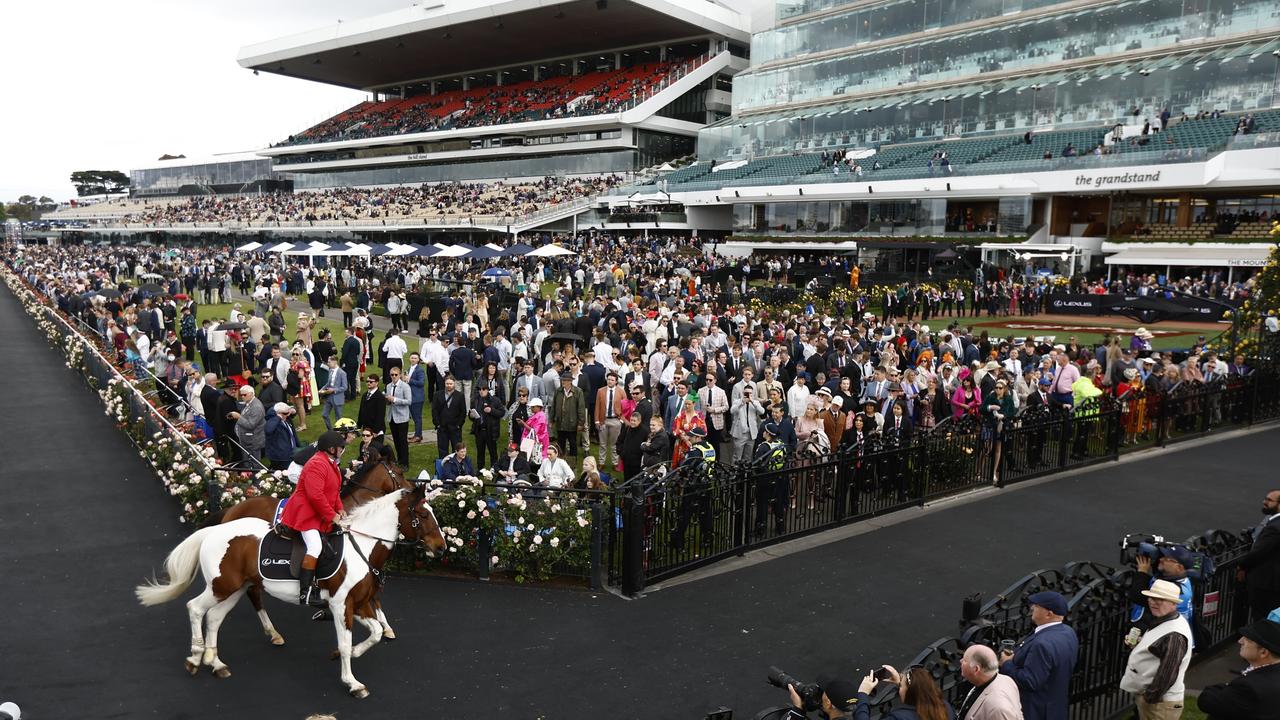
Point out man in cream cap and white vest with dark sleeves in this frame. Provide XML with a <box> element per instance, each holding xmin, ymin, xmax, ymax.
<box><xmin>1120</xmin><ymin>580</ymin><xmax>1192</xmax><ymax>720</ymax></box>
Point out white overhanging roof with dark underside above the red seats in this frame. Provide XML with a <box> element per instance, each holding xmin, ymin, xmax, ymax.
<box><xmin>237</xmin><ymin>0</ymin><xmax>762</xmax><ymax>90</ymax></box>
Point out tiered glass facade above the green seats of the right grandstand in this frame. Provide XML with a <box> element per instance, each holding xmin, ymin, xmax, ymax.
<box><xmin>698</xmin><ymin>0</ymin><xmax>1280</xmax><ymax>159</ymax></box>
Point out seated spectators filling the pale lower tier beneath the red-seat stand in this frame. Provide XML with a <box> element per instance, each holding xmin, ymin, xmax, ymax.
<box><xmin>118</xmin><ymin>176</ymin><xmax>622</xmax><ymax>224</ymax></box>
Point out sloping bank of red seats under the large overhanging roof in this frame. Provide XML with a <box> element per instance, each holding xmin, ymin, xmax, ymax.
<box><xmin>280</xmin><ymin>60</ymin><xmax>696</xmax><ymax>145</ymax></box>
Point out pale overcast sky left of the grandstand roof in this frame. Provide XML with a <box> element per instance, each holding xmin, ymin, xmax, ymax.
<box><xmin>0</xmin><ymin>0</ymin><xmax>411</xmax><ymax>201</ymax></box>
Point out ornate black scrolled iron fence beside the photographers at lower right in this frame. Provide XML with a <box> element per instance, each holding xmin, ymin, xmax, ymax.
<box><xmin>873</xmin><ymin>530</ymin><xmax>1252</xmax><ymax>720</ymax></box>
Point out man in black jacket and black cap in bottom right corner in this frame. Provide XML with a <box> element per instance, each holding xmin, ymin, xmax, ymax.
<box><xmin>1197</xmin><ymin>620</ymin><xmax>1280</xmax><ymax>720</ymax></box>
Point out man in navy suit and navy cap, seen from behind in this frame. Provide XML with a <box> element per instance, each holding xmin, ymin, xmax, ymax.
<box><xmin>1000</xmin><ymin>591</ymin><xmax>1080</xmax><ymax>720</ymax></box>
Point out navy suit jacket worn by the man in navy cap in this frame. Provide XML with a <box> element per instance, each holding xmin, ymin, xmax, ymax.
<box><xmin>1000</xmin><ymin>624</ymin><xmax>1080</xmax><ymax>720</ymax></box>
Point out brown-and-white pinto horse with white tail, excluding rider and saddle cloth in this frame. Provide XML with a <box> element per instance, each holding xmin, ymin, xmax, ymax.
<box><xmin>134</xmin><ymin>487</ymin><xmax>445</xmax><ymax>698</ymax></box>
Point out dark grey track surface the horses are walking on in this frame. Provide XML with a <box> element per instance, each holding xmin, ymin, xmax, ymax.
<box><xmin>0</xmin><ymin>281</ymin><xmax>1280</xmax><ymax>719</ymax></box>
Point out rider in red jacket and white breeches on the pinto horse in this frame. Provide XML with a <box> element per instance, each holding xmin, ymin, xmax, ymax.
<box><xmin>280</xmin><ymin>430</ymin><xmax>347</xmax><ymax>607</ymax></box>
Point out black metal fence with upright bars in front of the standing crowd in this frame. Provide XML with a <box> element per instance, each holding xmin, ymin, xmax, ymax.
<box><xmin>609</xmin><ymin>373</ymin><xmax>1280</xmax><ymax>594</ymax></box>
